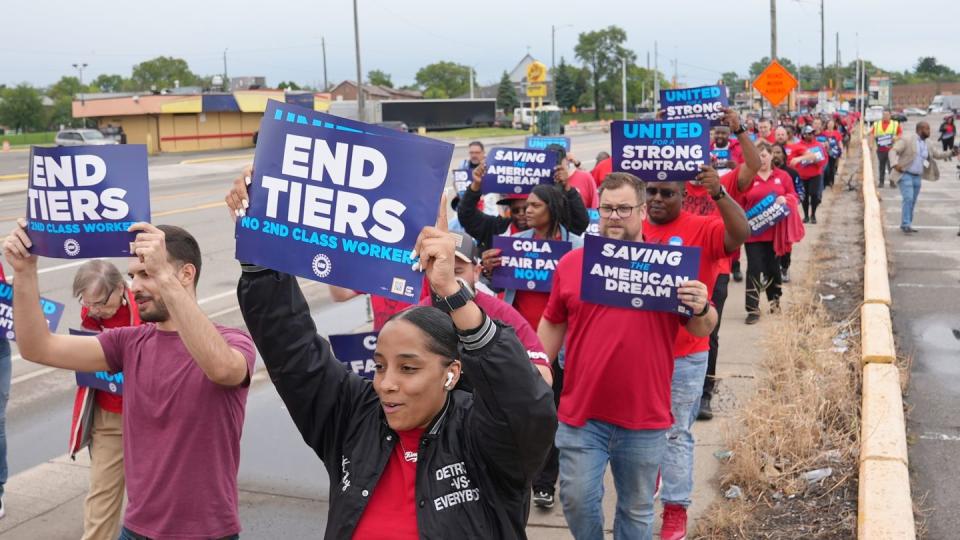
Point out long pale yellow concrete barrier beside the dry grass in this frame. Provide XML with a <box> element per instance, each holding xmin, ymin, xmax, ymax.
<box><xmin>857</xmin><ymin>139</ymin><xmax>916</xmax><ymax>540</ymax></box>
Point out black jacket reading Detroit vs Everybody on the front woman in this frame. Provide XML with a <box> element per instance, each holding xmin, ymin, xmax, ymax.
<box><xmin>237</xmin><ymin>268</ymin><xmax>557</xmax><ymax>540</ymax></box>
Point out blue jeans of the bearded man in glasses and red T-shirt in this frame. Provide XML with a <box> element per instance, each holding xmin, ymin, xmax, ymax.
<box><xmin>556</xmin><ymin>420</ymin><xmax>668</xmax><ymax>540</ymax></box>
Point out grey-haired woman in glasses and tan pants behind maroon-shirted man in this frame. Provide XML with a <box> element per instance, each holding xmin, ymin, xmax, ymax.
<box><xmin>70</xmin><ymin>259</ymin><xmax>140</xmax><ymax>540</ymax></box>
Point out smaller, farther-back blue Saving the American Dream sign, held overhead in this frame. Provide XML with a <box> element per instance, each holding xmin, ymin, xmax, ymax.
<box><xmin>481</xmin><ymin>148</ymin><xmax>557</xmax><ymax>193</ymax></box>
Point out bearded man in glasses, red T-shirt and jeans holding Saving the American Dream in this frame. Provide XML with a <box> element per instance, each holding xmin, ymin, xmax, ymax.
<box><xmin>537</xmin><ymin>173</ymin><xmax>717</xmax><ymax>538</ymax></box>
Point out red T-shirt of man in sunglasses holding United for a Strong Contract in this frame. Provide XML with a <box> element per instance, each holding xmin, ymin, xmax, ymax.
<box><xmin>643</xmin><ymin>211</ymin><xmax>731</xmax><ymax>358</ymax></box>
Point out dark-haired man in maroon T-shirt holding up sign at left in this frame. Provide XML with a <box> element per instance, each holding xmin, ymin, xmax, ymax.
<box><xmin>3</xmin><ymin>219</ymin><xmax>256</xmax><ymax>539</ymax></box>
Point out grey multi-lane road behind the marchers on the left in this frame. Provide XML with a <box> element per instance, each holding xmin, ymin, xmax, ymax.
<box><xmin>0</xmin><ymin>127</ymin><xmax>609</xmax><ymax>538</ymax></box>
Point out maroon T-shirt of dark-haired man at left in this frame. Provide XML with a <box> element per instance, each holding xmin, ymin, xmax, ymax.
<box><xmin>97</xmin><ymin>324</ymin><xmax>257</xmax><ymax>538</ymax></box>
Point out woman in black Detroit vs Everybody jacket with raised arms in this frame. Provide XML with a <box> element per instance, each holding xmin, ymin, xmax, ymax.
<box><xmin>228</xmin><ymin>192</ymin><xmax>557</xmax><ymax>539</ymax></box>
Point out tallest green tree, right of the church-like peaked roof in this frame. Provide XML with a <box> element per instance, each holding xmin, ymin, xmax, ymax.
<box><xmin>573</xmin><ymin>26</ymin><xmax>637</xmax><ymax>119</ymax></box>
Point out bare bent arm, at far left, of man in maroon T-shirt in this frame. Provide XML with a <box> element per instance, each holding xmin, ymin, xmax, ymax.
<box><xmin>3</xmin><ymin>219</ymin><xmax>110</xmax><ymax>372</ymax></box>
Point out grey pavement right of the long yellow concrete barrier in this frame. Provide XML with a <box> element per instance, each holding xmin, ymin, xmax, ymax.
<box><xmin>880</xmin><ymin>115</ymin><xmax>960</xmax><ymax>538</ymax></box>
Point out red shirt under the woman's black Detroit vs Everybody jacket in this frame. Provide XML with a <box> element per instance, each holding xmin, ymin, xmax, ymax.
<box><xmin>353</xmin><ymin>428</ymin><xmax>424</xmax><ymax>540</ymax></box>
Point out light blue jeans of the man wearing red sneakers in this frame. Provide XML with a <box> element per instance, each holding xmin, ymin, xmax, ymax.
<box><xmin>660</xmin><ymin>351</ymin><xmax>709</xmax><ymax>508</ymax></box>
